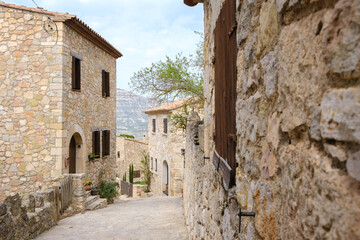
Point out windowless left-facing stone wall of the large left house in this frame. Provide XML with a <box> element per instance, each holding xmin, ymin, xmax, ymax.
<box><xmin>0</xmin><ymin>6</ymin><xmax>62</xmax><ymax>200</ymax></box>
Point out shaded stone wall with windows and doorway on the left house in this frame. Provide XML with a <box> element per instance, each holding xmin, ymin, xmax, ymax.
<box><xmin>59</xmin><ymin>23</ymin><xmax>116</xmax><ymax>183</ymax></box>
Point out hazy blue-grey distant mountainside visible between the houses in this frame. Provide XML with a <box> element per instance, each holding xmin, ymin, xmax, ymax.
<box><xmin>116</xmin><ymin>89</ymin><xmax>156</xmax><ymax>139</ymax></box>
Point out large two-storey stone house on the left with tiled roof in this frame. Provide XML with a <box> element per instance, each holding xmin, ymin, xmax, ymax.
<box><xmin>0</xmin><ymin>2</ymin><xmax>122</xmax><ymax>200</ymax></box>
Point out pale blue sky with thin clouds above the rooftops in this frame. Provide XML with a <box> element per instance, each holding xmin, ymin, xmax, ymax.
<box><xmin>6</xmin><ymin>0</ymin><xmax>204</xmax><ymax>90</ymax></box>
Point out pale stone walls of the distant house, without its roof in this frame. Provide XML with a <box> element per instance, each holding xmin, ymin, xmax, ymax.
<box><xmin>148</xmin><ymin>110</ymin><xmax>185</xmax><ymax>196</ymax></box>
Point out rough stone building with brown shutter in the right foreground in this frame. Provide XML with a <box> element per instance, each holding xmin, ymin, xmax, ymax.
<box><xmin>184</xmin><ymin>0</ymin><xmax>360</xmax><ymax>239</ymax></box>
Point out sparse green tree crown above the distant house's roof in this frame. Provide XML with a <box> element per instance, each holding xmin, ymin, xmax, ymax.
<box><xmin>129</xmin><ymin>33</ymin><xmax>204</xmax><ymax>106</ymax></box>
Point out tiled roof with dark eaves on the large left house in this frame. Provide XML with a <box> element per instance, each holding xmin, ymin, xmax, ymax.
<box><xmin>0</xmin><ymin>1</ymin><xmax>122</xmax><ymax>58</ymax></box>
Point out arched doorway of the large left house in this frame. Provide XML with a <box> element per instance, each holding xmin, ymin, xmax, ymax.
<box><xmin>68</xmin><ymin>132</ymin><xmax>84</xmax><ymax>174</ymax></box>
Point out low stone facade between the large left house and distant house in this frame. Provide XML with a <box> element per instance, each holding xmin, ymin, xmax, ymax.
<box><xmin>116</xmin><ymin>137</ymin><xmax>148</xmax><ymax>182</ymax></box>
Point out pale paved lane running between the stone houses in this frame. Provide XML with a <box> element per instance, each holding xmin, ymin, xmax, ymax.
<box><xmin>36</xmin><ymin>197</ymin><xmax>188</xmax><ymax>240</ymax></box>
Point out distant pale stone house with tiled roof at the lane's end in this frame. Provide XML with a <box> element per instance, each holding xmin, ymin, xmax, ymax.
<box><xmin>144</xmin><ymin>99</ymin><xmax>187</xmax><ymax>196</ymax></box>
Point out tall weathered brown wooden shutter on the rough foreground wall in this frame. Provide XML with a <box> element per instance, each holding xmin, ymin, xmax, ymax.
<box><xmin>214</xmin><ymin>0</ymin><xmax>237</xmax><ymax>188</ymax></box>
